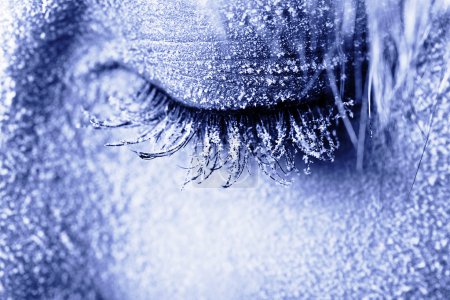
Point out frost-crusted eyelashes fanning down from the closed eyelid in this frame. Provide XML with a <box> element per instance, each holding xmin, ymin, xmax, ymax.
<box><xmin>91</xmin><ymin>84</ymin><xmax>348</xmax><ymax>187</ymax></box>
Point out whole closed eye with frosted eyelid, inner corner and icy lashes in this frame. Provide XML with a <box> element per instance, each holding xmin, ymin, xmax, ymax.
<box><xmin>59</xmin><ymin>1</ymin><xmax>372</xmax><ymax>186</ymax></box>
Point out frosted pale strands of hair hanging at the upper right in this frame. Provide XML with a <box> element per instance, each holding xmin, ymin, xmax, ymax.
<box><xmin>365</xmin><ymin>0</ymin><xmax>450</xmax><ymax>126</ymax></box>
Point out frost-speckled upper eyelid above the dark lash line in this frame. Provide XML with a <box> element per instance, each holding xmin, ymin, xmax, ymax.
<box><xmin>98</xmin><ymin>0</ymin><xmax>364</xmax><ymax>110</ymax></box>
